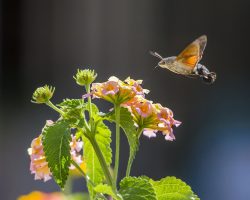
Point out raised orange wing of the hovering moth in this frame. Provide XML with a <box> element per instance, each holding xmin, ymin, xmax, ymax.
<box><xmin>176</xmin><ymin>35</ymin><xmax>207</xmax><ymax>69</ymax></box>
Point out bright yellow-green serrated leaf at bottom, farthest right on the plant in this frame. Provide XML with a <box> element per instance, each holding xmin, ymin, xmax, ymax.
<box><xmin>150</xmin><ymin>177</ymin><xmax>199</xmax><ymax>200</ymax></box>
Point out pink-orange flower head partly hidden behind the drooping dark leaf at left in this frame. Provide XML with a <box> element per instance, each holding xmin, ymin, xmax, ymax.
<box><xmin>28</xmin><ymin>120</ymin><xmax>83</xmax><ymax>182</ymax></box>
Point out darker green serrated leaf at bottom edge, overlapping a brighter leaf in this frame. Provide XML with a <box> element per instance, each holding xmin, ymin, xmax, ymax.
<box><xmin>120</xmin><ymin>177</ymin><xmax>157</xmax><ymax>200</ymax></box>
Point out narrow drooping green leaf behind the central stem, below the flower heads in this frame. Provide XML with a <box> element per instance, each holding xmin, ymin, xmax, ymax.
<box><xmin>104</xmin><ymin>107</ymin><xmax>139</xmax><ymax>172</ymax></box>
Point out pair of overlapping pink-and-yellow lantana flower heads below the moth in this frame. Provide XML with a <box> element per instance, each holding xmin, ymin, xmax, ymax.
<box><xmin>92</xmin><ymin>76</ymin><xmax>181</xmax><ymax>141</ymax></box>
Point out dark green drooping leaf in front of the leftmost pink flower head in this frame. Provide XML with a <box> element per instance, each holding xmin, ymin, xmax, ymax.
<box><xmin>42</xmin><ymin>120</ymin><xmax>71</xmax><ymax>188</ymax></box>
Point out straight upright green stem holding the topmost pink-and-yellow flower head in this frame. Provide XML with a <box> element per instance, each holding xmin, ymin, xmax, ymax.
<box><xmin>114</xmin><ymin>105</ymin><xmax>121</xmax><ymax>184</ymax></box>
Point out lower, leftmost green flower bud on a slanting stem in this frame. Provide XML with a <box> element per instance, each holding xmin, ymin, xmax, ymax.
<box><xmin>32</xmin><ymin>85</ymin><xmax>55</xmax><ymax>103</ymax></box>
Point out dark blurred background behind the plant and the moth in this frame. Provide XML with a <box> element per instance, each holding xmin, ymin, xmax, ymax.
<box><xmin>0</xmin><ymin>0</ymin><xmax>250</xmax><ymax>200</ymax></box>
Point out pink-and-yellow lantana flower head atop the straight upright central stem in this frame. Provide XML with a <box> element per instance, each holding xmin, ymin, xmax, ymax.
<box><xmin>91</xmin><ymin>76</ymin><xmax>149</xmax><ymax>104</ymax></box>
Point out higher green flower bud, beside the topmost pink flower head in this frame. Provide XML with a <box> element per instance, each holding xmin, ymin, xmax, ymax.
<box><xmin>74</xmin><ymin>69</ymin><xmax>97</xmax><ymax>86</ymax></box>
